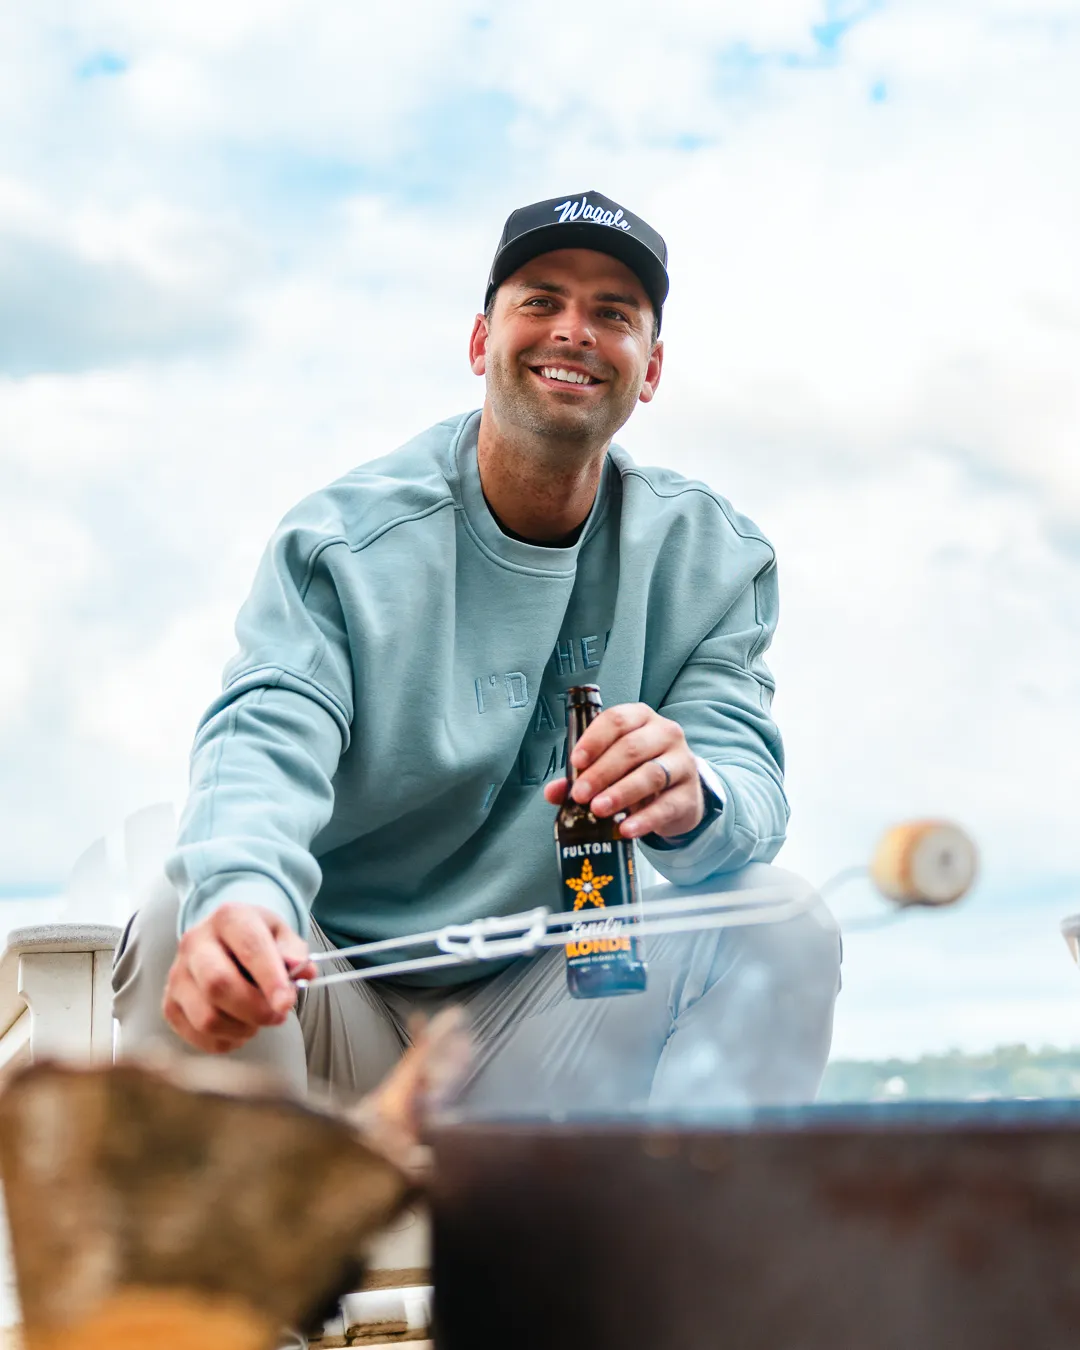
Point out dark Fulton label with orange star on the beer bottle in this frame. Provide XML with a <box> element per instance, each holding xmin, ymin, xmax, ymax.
<box><xmin>559</xmin><ymin>840</ymin><xmax>641</xmax><ymax>969</ymax></box>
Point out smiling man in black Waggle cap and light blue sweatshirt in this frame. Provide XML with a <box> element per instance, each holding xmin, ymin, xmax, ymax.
<box><xmin>115</xmin><ymin>192</ymin><xmax>840</xmax><ymax>1111</ymax></box>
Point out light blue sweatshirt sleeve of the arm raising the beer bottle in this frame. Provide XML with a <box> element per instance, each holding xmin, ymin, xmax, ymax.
<box><xmin>643</xmin><ymin>556</ymin><xmax>790</xmax><ymax>886</ymax></box>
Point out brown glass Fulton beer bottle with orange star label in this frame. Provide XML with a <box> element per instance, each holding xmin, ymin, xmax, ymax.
<box><xmin>555</xmin><ymin>684</ymin><xmax>645</xmax><ymax>999</ymax></box>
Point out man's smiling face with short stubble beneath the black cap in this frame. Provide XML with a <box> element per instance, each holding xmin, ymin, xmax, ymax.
<box><xmin>470</xmin><ymin>248</ymin><xmax>663</xmax><ymax>446</ymax></box>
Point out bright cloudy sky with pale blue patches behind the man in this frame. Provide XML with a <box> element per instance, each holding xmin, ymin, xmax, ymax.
<box><xmin>0</xmin><ymin>0</ymin><xmax>1080</xmax><ymax>1054</ymax></box>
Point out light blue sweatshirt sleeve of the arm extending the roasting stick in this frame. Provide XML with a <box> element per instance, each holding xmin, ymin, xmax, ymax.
<box><xmin>165</xmin><ymin>521</ymin><xmax>352</xmax><ymax>934</ymax></box>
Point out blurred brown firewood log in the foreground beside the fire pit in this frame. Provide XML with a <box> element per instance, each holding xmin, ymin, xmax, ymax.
<box><xmin>0</xmin><ymin>1017</ymin><xmax>467</xmax><ymax>1350</ymax></box>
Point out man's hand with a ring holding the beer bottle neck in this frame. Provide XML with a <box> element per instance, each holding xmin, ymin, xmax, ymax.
<box><xmin>544</xmin><ymin>703</ymin><xmax>705</xmax><ymax>838</ymax></box>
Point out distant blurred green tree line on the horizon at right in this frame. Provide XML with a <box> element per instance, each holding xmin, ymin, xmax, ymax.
<box><xmin>819</xmin><ymin>1045</ymin><xmax>1080</xmax><ymax>1102</ymax></box>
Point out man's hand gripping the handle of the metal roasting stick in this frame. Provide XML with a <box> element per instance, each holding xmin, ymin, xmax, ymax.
<box><xmin>163</xmin><ymin>905</ymin><xmax>316</xmax><ymax>1054</ymax></box>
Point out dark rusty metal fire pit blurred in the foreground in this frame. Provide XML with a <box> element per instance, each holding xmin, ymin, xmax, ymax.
<box><xmin>433</xmin><ymin>1102</ymin><xmax>1080</xmax><ymax>1350</ymax></box>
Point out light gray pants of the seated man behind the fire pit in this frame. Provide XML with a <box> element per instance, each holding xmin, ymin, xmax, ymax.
<box><xmin>113</xmin><ymin>863</ymin><xmax>840</xmax><ymax>1115</ymax></box>
